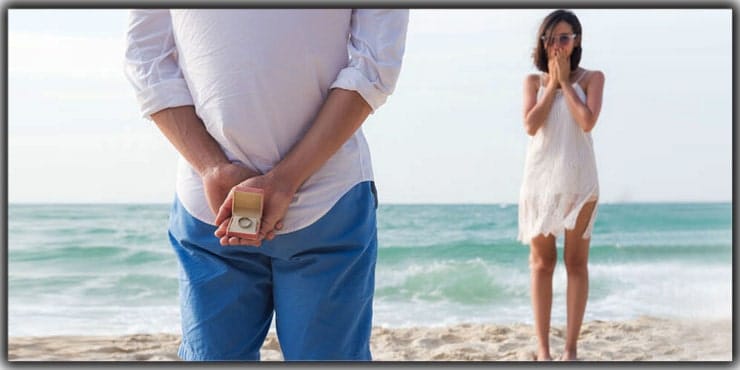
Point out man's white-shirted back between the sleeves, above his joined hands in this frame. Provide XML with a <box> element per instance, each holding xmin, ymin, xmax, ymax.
<box><xmin>171</xmin><ymin>9</ymin><xmax>351</xmax><ymax>160</ymax></box>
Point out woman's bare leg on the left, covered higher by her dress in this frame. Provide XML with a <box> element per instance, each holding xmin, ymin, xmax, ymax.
<box><xmin>529</xmin><ymin>235</ymin><xmax>558</xmax><ymax>361</ymax></box>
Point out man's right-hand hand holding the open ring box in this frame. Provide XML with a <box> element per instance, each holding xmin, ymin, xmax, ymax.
<box><xmin>215</xmin><ymin>172</ymin><xmax>296</xmax><ymax>247</ymax></box>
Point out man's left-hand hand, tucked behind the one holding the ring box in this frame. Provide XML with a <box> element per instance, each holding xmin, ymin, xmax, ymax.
<box><xmin>201</xmin><ymin>163</ymin><xmax>259</xmax><ymax>220</ymax></box>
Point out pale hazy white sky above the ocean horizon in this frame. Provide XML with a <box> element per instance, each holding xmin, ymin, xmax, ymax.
<box><xmin>7</xmin><ymin>9</ymin><xmax>732</xmax><ymax>204</ymax></box>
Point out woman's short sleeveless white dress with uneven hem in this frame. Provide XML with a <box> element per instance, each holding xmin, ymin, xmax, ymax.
<box><xmin>517</xmin><ymin>72</ymin><xmax>599</xmax><ymax>244</ymax></box>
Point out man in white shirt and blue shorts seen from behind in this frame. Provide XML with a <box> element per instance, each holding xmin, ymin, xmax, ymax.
<box><xmin>126</xmin><ymin>9</ymin><xmax>408</xmax><ymax>360</ymax></box>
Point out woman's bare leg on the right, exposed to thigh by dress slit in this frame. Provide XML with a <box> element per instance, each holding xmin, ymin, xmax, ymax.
<box><xmin>561</xmin><ymin>201</ymin><xmax>596</xmax><ymax>360</ymax></box>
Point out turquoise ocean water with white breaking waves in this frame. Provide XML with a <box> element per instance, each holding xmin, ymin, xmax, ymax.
<box><xmin>8</xmin><ymin>203</ymin><xmax>732</xmax><ymax>336</ymax></box>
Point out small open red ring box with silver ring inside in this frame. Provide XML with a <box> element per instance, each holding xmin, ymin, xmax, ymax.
<box><xmin>226</xmin><ymin>188</ymin><xmax>263</xmax><ymax>239</ymax></box>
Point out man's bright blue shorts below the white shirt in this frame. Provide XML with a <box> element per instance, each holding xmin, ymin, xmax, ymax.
<box><xmin>169</xmin><ymin>182</ymin><xmax>377</xmax><ymax>361</ymax></box>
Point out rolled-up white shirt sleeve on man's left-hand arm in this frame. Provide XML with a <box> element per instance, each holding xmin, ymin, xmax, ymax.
<box><xmin>124</xmin><ymin>9</ymin><xmax>193</xmax><ymax>119</ymax></box>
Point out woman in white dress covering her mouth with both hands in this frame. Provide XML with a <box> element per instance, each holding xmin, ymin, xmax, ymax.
<box><xmin>518</xmin><ymin>10</ymin><xmax>604</xmax><ymax>360</ymax></box>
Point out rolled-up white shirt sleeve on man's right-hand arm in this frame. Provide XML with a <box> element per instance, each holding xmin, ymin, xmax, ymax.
<box><xmin>331</xmin><ymin>9</ymin><xmax>409</xmax><ymax>111</ymax></box>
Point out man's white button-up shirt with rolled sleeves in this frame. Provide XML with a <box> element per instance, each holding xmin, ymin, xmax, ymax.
<box><xmin>125</xmin><ymin>9</ymin><xmax>408</xmax><ymax>233</ymax></box>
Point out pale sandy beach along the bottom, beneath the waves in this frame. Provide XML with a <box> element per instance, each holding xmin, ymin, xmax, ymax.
<box><xmin>8</xmin><ymin>317</ymin><xmax>732</xmax><ymax>361</ymax></box>
